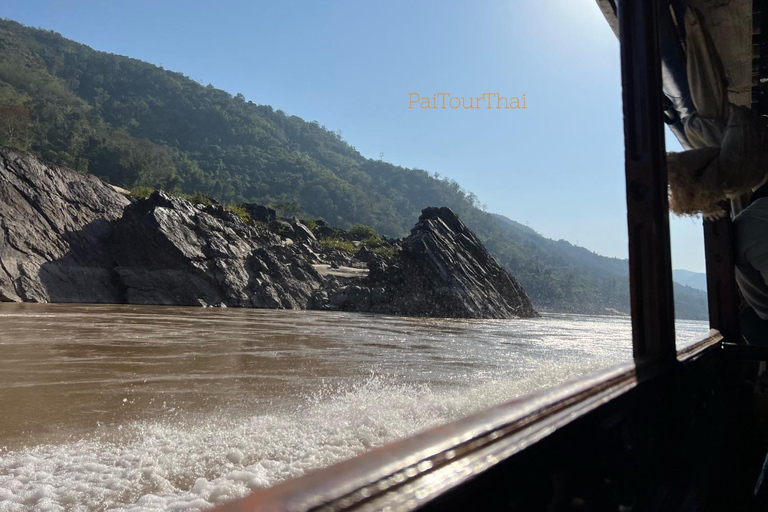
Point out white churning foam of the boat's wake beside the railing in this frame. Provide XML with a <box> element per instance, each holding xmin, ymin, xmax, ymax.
<box><xmin>0</xmin><ymin>368</ymin><xmax>592</xmax><ymax>512</ymax></box>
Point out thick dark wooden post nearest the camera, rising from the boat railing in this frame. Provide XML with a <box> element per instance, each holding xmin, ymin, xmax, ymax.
<box><xmin>618</xmin><ymin>0</ymin><xmax>676</xmax><ymax>367</ymax></box>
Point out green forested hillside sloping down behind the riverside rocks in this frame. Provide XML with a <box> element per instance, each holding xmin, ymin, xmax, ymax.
<box><xmin>0</xmin><ymin>20</ymin><xmax>706</xmax><ymax>317</ymax></box>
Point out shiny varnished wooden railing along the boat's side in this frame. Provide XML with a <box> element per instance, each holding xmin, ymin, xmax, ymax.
<box><xmin>216</xmin><ymin>330</ymin><xmax>722</xmax><ymax>512</ymax></box>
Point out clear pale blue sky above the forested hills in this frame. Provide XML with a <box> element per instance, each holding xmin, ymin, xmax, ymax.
<box><xmin>0</xmin><ymin>0</ymin><xmax>704</xmax><ymax>271</ymax></box>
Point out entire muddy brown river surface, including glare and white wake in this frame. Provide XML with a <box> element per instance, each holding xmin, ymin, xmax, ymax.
<box><xmin>0</xmin><ymin>304</ymin><xmax>707</xmax><ymax>511</ymax></box>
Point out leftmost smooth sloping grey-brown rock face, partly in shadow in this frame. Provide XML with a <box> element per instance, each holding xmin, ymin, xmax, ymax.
<box><xmin>0</xmin><ymin>148</ymin><xmax>129</xmax><ymax>302</ymax></box>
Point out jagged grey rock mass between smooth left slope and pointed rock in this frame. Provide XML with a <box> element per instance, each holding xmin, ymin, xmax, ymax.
<box><xmin>110</xmin><ymin>192</ymin><xmax>323</xmax><ymax>309</ymax></box>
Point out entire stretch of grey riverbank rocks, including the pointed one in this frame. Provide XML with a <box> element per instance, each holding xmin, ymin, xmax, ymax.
<box><xmin>0</xmin><ymin>147</ymin><xmax>537</xmax><ymax>318</ymax></box>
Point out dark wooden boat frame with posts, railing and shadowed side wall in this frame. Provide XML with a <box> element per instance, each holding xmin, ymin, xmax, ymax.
<box><xmin>213</xmin><ymin>0</ymin><xmax>768</xmax><ymax>512</ymax></box>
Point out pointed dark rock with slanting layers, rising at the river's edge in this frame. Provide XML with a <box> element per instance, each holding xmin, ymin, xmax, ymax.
<box><xmin>308</xmin><ymin>208</ymin><xmax>538</xmax><ymax>318</ymax></box>
